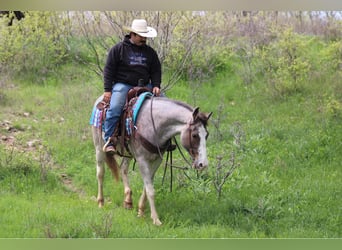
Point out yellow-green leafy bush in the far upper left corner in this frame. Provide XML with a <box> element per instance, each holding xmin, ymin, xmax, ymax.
<box><xmin>0</xmin><ymin>11</ymin><xmax>66</xmax><ymax>80</ymax></box>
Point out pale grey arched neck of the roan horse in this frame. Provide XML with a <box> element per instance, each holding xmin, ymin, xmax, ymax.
<box><xmin>139</xmin><ymin>98</ymin><xmax>192</xmax><ymax>143</ymax></box>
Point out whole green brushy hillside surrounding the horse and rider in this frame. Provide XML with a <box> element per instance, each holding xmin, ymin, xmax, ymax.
<box><xmin>0</xmin><ymin>12</ymin><xmax>342</xmax><ymax>239</ymax></box>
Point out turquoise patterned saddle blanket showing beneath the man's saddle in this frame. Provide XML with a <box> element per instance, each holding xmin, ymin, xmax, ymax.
<box><xmin>89</xmin><ymin>92</ymin><xmax>153</xmax><ymax>130</ymax></box>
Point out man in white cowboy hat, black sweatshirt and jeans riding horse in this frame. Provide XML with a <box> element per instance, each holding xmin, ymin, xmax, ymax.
<box><xmin>103</xmin><ymin>19</ymin><xmax>162</xmax><ymax>153</ymax></box>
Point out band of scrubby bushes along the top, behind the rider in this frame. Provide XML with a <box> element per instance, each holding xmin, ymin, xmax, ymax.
<box><xmin>0</xmin><ymin>11</ymin><xmax>341</xmax><ymax>88</ymax></box>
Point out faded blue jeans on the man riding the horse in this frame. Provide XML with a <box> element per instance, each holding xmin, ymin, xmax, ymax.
<box><xmin>104</xmin><ymin>83</ymin><xmax>152</xmax><ymax>143</ymax></box>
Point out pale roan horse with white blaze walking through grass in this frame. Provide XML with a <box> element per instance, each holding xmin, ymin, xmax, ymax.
<box><xmin>92</xmin><ymin>94</ymin><xmax>211</xmax><ymax>225</ymax></box>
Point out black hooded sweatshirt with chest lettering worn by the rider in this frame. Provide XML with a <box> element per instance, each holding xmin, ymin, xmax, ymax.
<box><xmin>103</xmin><ymin>35</ymin><xmax>161</xmax><ymax>92</ymax></box>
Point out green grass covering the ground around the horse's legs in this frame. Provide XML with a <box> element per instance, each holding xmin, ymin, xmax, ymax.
<box><xmin>0</xmin><ymin>57</ymin><xmax>342</xmax><ymax>238</ymax></box>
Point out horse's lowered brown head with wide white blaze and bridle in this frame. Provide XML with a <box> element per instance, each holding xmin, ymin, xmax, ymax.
<box><xmin>180</xmin><ymin>107</ymin><xmax>212</xmax><ymax>170</ymax></box>
